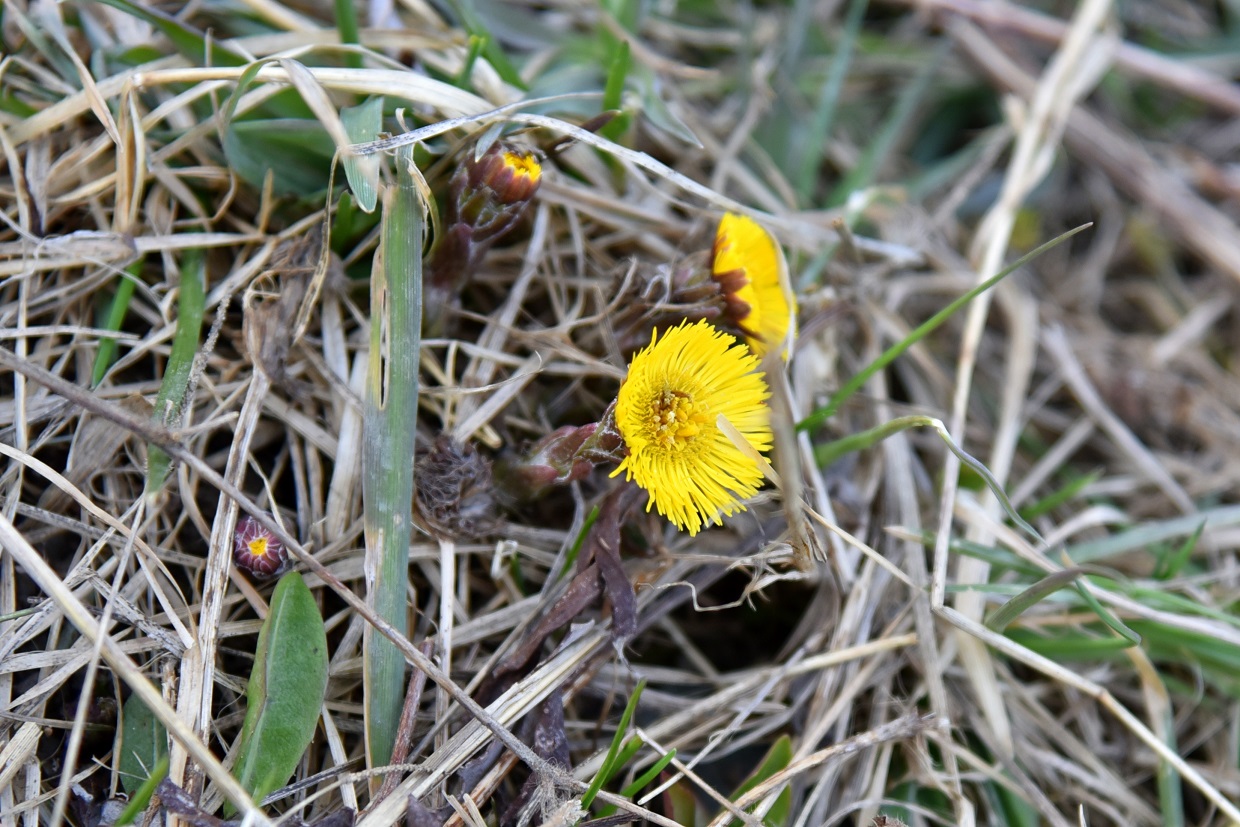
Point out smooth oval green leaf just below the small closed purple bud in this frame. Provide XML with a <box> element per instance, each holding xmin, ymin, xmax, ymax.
<box><xmin>233</xmin><ymin>572</ymin><xmax>327</xmax><ymax>801</ymax></box>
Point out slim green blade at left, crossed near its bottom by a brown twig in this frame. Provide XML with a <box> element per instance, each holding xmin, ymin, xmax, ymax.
<box><xmin>146</xmin><ymin>249</ymin><xmax>207</xmax><ymax>497</ymax></box>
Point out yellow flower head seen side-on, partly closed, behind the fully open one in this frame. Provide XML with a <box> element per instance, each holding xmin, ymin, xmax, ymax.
<box><xmin>711</xmin><ymin>213</ymin><xmax>796</xmax><ymax>356</ymax></box>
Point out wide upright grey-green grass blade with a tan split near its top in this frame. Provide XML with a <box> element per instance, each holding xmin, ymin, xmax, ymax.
<box><xmin>362</xmin><ymin>148</ymin><xmax>425</xmax><ymax>766</ymax></box>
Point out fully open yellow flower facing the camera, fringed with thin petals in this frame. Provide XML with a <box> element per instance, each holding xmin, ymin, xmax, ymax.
<box><xmin>611</xmin><ymin>321</ymin><xmax>771</xmax><ymax>534</ymax></box>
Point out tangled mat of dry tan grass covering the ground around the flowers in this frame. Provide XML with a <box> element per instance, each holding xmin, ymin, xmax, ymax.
<box><xmin>0</xmin><ymin>0</ymin><xmax>1240</xmax><ymax>827</ymax></box>
